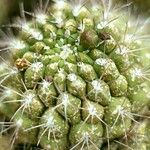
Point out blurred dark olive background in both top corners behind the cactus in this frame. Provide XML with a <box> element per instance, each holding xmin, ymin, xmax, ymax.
<box><xmin>0</xmin><ymin>0</ymin><xmax>150</xmax><ymax>24</ymax></box>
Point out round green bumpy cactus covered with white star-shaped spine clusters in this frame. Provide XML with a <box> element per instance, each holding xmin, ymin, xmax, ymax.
<box><xmin>0</xmin><ymin>0</ymin><xmax>150</xmax><ymax>150</ymax></box>
